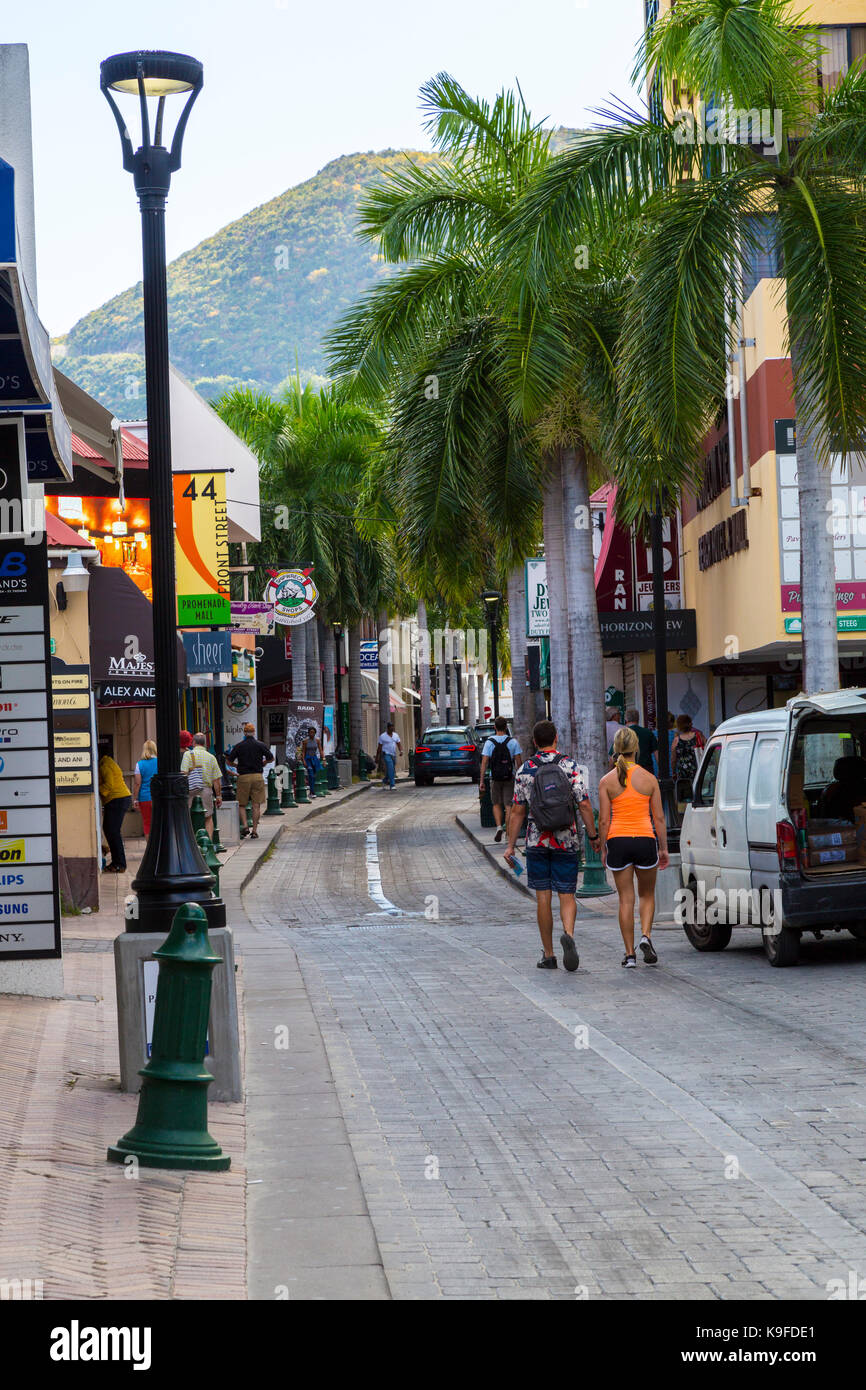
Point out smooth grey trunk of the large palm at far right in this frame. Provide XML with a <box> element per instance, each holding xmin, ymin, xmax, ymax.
<box><xmin>791</xmin><ymin>334</ymin><xmax>840</xmax><ymax>695</ymax></box>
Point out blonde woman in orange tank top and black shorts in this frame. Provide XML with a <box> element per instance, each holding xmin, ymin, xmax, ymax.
<box><xmin>598</xmin><ymin>728</ymin><xmax>669</xmax><ymax>970</ymax></box>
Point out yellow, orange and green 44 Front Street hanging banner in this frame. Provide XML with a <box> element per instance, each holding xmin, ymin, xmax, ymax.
<box><xmin>172</xmin><ymin>473</ymin><xmax>232</xmax><ymax>627</ymax></box>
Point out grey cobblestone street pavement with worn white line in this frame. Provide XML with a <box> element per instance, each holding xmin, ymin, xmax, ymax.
<box><xmin>245</xmin><ymin>783</ymin><xmax>866</xmax><ymax>1300</ymax></box>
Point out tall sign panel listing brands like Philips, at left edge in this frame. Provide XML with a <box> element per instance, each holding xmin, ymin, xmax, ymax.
<box><xmin>0</xmin><ymin>535</ymin><xmax>61</xmax><ymax>962</ymax></box>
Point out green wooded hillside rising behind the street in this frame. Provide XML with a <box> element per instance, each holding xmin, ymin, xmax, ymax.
<box><xmin>53</xmin><ymin>131</ymin><xmax>577</xmax><ymax>418</ymax></box>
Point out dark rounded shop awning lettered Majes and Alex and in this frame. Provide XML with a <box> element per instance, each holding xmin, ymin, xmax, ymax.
<box><xmin>89</xmin><ymin>564</ymin><xmax>186</xmax><ymax>705</ymax></box>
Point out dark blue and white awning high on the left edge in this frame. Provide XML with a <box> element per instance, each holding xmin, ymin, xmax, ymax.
<box><xmin>0</xmin><ymin>158</ymin><xmax>72</xmax><ymax>482</ymax></box>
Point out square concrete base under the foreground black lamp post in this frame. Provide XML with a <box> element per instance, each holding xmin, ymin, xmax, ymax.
<box><xmin>114</xmin><ymin>928</ymin><xmax>243</xmax><ymax>1101</ymax></box>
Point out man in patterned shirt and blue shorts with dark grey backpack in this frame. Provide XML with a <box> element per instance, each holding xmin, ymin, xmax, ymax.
<box><xmin>505</xmin><ymin>719</ymin><xmax>598</xmax><ymax>970</ymax></box>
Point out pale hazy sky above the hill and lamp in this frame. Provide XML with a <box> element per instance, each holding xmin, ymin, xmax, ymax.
<box><xmin>10</xmin><ymin>0</ymin><xmax>644</xmax><ymax>334</ymax></box>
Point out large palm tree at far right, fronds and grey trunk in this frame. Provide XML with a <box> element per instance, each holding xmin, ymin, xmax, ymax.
<box><xmin>509</xmin><ymin>0</ymin><xmax>866</xmax><ymax>691</ymax></box>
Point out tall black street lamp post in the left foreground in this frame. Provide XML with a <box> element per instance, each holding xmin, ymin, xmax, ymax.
<box><xmin>100</xmin><ymin>51</ymin><xmax>225</xmax><ymax>934</ymax></box>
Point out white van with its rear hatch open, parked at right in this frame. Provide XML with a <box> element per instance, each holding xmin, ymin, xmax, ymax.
<box><xmin>678</xmin><ymin>688</ymin><xmax>866</xmax><ymax>966</ymax></box>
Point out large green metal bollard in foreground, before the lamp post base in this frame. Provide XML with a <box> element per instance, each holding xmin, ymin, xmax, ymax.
<box><xmin>108</xmin><ymin>902</ymin><xmax>231</xmax><ymax>1172</ymax></box>
